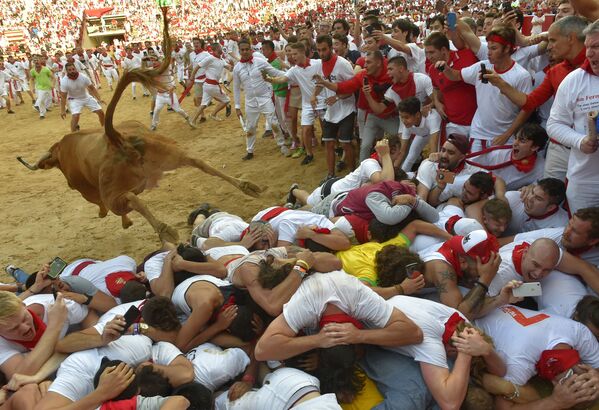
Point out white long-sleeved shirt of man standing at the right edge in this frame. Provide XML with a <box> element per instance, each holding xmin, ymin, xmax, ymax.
<box><xmin>547</xmin><ymin>68</ymin><xmax>599</xmax><ymax>184</ymax></box>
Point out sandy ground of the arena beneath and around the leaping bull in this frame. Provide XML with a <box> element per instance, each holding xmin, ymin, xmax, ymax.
<box><xmin>0</xmin><ymin>77</ymin><xmax>326</xmax><ymax>281</ymax></box>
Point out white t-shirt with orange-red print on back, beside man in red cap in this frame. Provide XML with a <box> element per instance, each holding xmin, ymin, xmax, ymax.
<box><xmin>475</xmin><ymin>305</ymin><xmax>599</xmax><ymax>385</ymax></box>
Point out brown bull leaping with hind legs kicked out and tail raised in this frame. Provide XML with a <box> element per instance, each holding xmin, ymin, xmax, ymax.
<box><xmin>17</xmin><ymin>11</ymin><xmax>261</xmax><ymax>242</ymax></box>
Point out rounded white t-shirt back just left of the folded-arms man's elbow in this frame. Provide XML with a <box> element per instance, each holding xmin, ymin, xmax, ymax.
<box><xmin>185</xmin><ymin>343</ymin><xmax>250</xmax><ymax>391</ymax></box>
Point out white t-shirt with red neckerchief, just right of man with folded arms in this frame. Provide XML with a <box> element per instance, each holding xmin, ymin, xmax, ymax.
<box><xmin>387</xmin><ymin>296</ymin><xmax>467</xmax><ymax>369</ymax></box>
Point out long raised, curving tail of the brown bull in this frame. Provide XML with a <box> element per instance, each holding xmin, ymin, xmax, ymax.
<box><xmin>104</xmin><ymin>7</ymin><xmax>172</xmax><ymax>148</ymax></box>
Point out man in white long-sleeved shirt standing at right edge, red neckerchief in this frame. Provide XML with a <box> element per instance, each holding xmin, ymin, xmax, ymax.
<box><xmin>547</xmin><ymin>19</ymin><xmax>599</xmax><ymax>212</ymax></box>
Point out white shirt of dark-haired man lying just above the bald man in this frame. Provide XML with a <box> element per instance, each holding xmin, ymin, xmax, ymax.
<box><xmin>505</xmin><ymin>191</ymin><xmax>569</xmax><ymax>236</ymax></box>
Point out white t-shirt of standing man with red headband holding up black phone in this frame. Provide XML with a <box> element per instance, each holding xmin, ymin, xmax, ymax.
<box><xmin>461</xmin><ymin>60</ymin><xmax>532</xmax><ymax>141</ymax></box>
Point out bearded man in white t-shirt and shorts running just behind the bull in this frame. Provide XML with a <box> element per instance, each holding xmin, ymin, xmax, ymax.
<box><xmin>60</xmin><ymin>63</ymin><xmax>104</xmax><ymax>132</ymax></box>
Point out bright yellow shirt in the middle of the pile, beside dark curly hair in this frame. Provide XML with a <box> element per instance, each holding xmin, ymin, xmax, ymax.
<box><xmin>337</xmin><ymin>233</ymin><xmax>410</xmax><ymax>286</ymax></box>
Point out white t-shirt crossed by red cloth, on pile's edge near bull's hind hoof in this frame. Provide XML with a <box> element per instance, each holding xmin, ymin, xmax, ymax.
<box><xmin>252</xmin><ymin>207</ymin><xmax>335</xmax><ymax>243</ymax></box>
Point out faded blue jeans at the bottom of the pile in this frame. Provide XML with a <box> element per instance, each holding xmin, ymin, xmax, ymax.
<box><xmin>360</xmin><ymin>346</ymin><xmax>438</xmax><ymax>410</ymax></box>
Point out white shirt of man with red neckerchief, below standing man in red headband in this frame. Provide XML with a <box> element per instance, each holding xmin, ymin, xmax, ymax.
<box><xmin>468</xmin><ymin>146</ymin><xmax>545</xmax><ymax>191</ymax></box>
